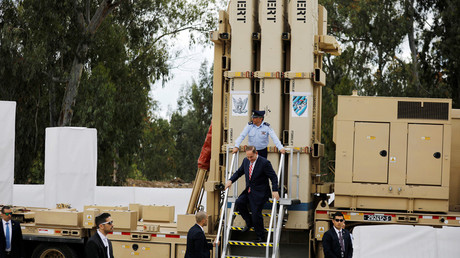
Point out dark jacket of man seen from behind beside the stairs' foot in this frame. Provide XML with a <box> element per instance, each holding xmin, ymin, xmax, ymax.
<box><xmin>185</xmin><ymin>224</ymin><xmax>212</xmax><ymax>258</ymax></box>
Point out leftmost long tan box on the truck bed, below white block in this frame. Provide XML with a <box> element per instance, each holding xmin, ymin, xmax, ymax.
<box><xmin>35</xmin><ymin>209</ymin><xmax>83</xmax><ymax>227</ymax></box>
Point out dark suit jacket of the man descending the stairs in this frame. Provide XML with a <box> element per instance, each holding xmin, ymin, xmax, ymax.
<box><xmin>230</xmin><ymin>155</ymin><xmax>278</xmax><ymax>203</ymax></box>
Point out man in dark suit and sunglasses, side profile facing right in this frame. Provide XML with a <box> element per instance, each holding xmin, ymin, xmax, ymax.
<box><xmin>85</xmin><ymin>213</ymin><xmax>113</xmax><ymax>258</ymax></box>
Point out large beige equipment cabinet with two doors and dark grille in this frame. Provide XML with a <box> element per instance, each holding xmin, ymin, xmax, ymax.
<box><xmin>334</xmin><ymin>96</ymin><xmax>452</xmax><ymax>212</ymax></box>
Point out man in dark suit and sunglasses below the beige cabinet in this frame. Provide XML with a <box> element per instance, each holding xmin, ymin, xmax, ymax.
<box><xmin>323</xmin><ymin>212</ymin><xmax>353</xmax><ymax>258</ymax></box>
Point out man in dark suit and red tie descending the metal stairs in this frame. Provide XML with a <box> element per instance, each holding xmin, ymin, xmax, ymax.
<box><xmin>225</xmin><ymin>146</ymin><xmax>280</xmax><ymax>242</ymax></box>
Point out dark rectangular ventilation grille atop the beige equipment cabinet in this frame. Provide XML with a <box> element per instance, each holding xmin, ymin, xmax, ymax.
<box><xmin>398</xmin><ymin>101</ymin><xmax>449</xmax><ymax>120</ymax></box>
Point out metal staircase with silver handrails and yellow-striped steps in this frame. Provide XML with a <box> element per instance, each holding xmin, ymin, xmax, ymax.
<box><xmin>215</xmin><ymin>149</ymin><xmax>298</xmax><ymax>258</ymax></box>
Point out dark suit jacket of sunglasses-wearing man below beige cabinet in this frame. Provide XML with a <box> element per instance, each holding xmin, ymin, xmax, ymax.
<box><xmin>323</xmin><ymin>227</ymin><xmax>353</xmax><ymax>258</ymax></box>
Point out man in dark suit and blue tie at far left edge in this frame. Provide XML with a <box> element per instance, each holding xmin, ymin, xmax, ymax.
<box><xmin>0</xmin><ymin>206</ymin><xmax>25</xmax><ymax>258</ymax></box>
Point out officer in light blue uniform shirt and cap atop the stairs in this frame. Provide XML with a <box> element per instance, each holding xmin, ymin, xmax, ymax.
<box><xmin>233</xmin><ymin>110</ymin><xmax>286</xmax><ymax>158</ymax></box>
